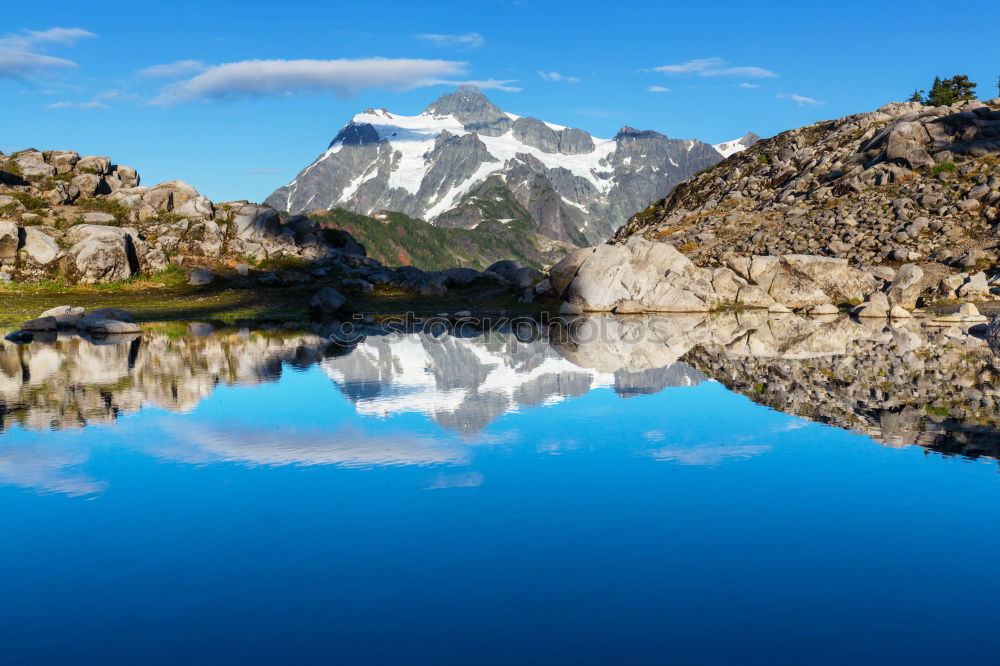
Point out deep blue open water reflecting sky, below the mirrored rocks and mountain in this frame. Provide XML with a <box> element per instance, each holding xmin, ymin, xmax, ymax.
<box><xmin>0</xmin><ymin>330</ymin><xmax>1000</xmax><ymax>664</ymax></box>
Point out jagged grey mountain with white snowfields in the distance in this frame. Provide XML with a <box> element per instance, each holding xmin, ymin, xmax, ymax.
<box><xmin>267</xmin><ymin>86</ymin><xmax>721</xmax><ymax>244</ymax></box>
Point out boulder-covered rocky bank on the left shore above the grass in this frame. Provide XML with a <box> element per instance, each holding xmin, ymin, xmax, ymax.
<box><xmin>0</xmin><ymin>150</ymin><xmax>365</xmax><ymax>284</ymax></box>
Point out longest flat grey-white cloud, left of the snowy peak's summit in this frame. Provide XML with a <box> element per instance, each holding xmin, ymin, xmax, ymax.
<box><xmin>152</xmin><ymin>58</ymin><xmax>474</xmax><ymax>105</ymax></box>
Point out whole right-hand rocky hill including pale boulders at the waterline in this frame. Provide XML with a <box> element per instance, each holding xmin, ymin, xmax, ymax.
<box><xmin>552</xmin><ymin>99</ymin><xmax>1000</xmax><ymax>317</ymax></box>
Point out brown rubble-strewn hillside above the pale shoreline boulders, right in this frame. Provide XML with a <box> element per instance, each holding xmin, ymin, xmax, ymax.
<box><xmin>615</xmin><ymin>98</ymin><xmax>1000</xmax><ymax>268</ymax></box>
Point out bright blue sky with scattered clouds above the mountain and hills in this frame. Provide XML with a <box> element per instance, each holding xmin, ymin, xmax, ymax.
<box><xmin>0</xmin><ymin>0</ymin><xmax>1000</xmax><ymax>201</ymax></box>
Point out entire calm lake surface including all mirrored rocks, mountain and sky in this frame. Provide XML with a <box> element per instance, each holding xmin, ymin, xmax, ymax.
<box><xmin>0</xmin><ymin>316</ymin><xmax>1000</xmax><ymax>664</ymax></box>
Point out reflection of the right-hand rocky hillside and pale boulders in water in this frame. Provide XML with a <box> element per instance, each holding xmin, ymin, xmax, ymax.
<box><xmin>554</xmin><ymin>312</ymin><xmax>1000</xmax><ymax>458</ymax></box>
